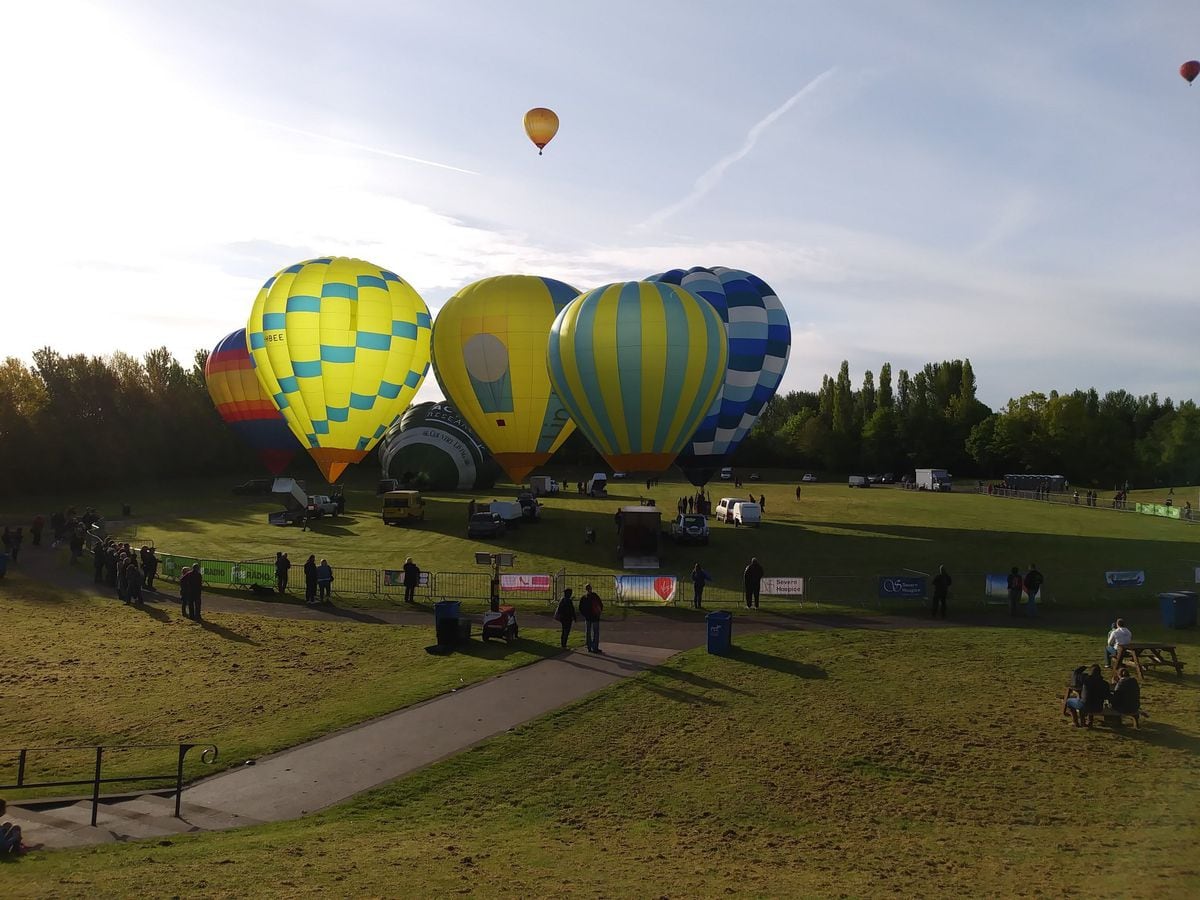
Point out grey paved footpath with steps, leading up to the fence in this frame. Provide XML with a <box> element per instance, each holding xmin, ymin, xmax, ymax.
<box><xmin>6</xmin><ymin>547</ymin><xmax>950</xmax><ymax>847</ymax></box>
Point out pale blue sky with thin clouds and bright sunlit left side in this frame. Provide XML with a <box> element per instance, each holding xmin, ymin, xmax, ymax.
<box><xmin>0</xmin><ymin>0</ymin><xmax>1200</xmax><ymax>407</ymax></box>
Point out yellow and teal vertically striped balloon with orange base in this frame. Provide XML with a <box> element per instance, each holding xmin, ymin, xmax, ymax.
<box><xmin>546</xmin><ymin>281</ymin><xmax>728</xmax><ymax>473</ymax></box>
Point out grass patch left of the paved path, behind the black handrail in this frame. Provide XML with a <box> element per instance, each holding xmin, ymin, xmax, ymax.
<box><xmin>0</xmin><ymin>572</ymin><xmax>576</xmax><ymax>797</ymax></box>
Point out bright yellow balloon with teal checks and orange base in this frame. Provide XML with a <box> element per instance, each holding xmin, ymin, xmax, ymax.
<box><xmin>246</xmin><ymin>257</ymin><xmax>430</xmax><ymax>482</ymax></box>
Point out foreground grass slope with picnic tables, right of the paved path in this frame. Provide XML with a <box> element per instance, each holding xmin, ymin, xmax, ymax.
<box><xmin>9</xmin><ymin>623</ymin><xmax>1200</xmax><ymax>898</ymax></box>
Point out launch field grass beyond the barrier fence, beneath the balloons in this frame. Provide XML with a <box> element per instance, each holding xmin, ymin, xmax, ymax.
<box><xmin>0</xmin><ymin>467</ymin><xmax>1200</xmax><ymax>611</ymax></box>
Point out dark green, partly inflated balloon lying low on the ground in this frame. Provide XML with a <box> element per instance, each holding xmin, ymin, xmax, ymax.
<box><xmin>379</xmin><ymin>403</ymin><xmax>500</xmax><ymax>491</ymax></box>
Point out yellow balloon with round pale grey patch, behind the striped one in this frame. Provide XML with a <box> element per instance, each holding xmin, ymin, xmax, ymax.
<box><xmin>432</xmin><ymin>275</ymin><xmax>580</xmax><ymax>484</ymax></box>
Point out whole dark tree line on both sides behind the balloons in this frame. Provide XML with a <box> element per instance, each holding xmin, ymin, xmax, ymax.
<box><xmin>0</xmin><ymin>348</ymin><xmax>1200</xmax><ymax>496</ymax></box>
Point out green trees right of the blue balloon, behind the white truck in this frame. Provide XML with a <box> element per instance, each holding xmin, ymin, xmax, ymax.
<box><xmin>737</xmin><ymin>360</ymin><xmax>1200</xmax><ymax>490</ymax></box>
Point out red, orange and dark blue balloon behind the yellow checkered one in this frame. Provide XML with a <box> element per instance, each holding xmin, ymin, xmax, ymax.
<box><xmin>204</xmin><ymin>328</ymin><xmax>300</xmax><ymax>475</ymax></box>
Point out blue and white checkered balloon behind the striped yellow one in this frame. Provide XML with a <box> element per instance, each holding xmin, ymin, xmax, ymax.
<box><xmin>648</xmin><ymin>266</ymin><xmax>792</xmax><ymax>487</ymax></box>
